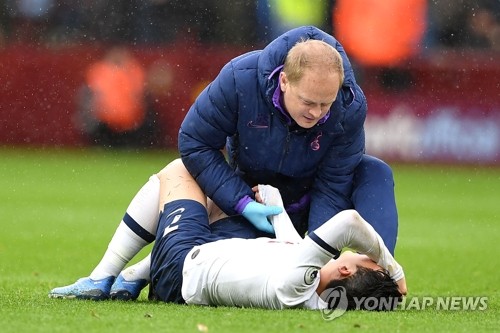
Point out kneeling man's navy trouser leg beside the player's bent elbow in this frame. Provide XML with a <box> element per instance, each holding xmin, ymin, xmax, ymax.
<box><xmin>352</xmin><ymin>155</ymin><xmax>398</xmax><ymax>255</ymax></box>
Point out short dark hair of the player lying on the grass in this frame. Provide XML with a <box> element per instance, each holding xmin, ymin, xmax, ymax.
<box><xmin>326</xmin><ymin>266</ymin><xmax>403</xmax><ymax>311</ymax></box>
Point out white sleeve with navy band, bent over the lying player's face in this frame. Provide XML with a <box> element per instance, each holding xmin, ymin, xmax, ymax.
<box><xmin>273</xmin><ymin>210</ymin><xmax>404</xmax><ymax>307</ymax></box>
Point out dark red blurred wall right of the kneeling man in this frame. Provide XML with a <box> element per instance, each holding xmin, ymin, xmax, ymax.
<box><xmin>361</xmin><ymin>51</ymin><xmax>500</xmax><ymax>117</ymax></box>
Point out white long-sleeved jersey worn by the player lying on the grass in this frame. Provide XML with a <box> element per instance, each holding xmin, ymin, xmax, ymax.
<box><xmin>182</xmin><ymin>186</ymin><xmax>404</xmax><ymax>309</ymax></box>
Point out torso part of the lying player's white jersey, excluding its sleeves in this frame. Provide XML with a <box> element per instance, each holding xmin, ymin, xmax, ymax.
<box><xmin>182</xmin><ymin>238</ymin><xmax>329</xmax><ymax>309</ymax></box>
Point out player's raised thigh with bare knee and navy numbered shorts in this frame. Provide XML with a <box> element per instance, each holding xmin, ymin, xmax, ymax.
<box><xmin>150</xmin><ymin>161</ymin><xmax>219</xmax><ymax>303</ymax></box>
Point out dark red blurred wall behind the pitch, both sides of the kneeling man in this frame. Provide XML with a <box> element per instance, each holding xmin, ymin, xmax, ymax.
<box><xmin>0</xmin><ymin>43</ymin><xmax>500</xmax><ymax>148</ymax></box>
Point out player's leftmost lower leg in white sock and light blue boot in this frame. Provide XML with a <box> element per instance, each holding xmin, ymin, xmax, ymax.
<box><xmin>49</xmin><ymin>171</ymin><xmax>160</xmax><ymax>300</ymax></box>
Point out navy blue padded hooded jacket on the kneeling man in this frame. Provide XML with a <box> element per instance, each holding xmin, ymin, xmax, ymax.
<box><xmin>179</xmin><ymin>27</ymin><xmax>367</xmax><ymax>230</ymax></box>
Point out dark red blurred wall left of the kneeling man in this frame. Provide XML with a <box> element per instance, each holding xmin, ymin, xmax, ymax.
<box><xmin>0</xmin><ymin>44</ymin><xmax>242</xmax><ymax>147</ymax></box>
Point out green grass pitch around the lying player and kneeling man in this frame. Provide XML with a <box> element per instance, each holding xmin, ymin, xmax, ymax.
<box><xmin>0</xmin><ymin>148</ymin><xmax>500</xmax><ymax>333</ymax></box>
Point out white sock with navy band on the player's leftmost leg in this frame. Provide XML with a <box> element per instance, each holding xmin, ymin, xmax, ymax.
<box><xmin>89</xmin><ymin>175</ymin><xmax>160</xmax><ymax>280</ymax></box>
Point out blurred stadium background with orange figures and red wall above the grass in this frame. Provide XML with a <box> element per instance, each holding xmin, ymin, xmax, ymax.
<box><xmin>0</xmin><ymin>0</ymin><xmax>500</xmax><ymax>165</ymax></box>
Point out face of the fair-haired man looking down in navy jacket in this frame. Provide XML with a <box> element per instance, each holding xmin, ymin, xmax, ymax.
<box><xmin>280</xmin><ymin>69</ymin><xmax>340</xmax><ymax>128</ymax></box>
